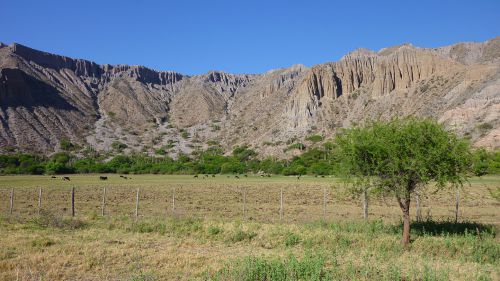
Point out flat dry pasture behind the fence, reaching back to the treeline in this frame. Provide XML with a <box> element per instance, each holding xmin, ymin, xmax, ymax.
<box><xmin>0</xmin><ymin>174</ymin><xmax>500</xmax><ymax>224</ymax></box>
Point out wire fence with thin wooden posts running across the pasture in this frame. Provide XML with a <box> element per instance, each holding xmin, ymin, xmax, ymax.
<box><xmin>0</xmin><ymin>184</ymin><xmax>494</xmax><ymax>223</ymax></box>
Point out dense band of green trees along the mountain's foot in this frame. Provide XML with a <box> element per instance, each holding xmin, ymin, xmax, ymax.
<box><xmin>0</xmin><ymin>142</ymin><xmax>500</xmax><ymax>176</ymax></box>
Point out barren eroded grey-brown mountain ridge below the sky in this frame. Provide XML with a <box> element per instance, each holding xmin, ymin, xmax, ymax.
<box><xmin>0</xmin><ymin>37</ymin><xmax>500</xmax><ymax>157</ymax></box>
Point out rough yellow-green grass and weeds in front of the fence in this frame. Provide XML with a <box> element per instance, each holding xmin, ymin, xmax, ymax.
<box><xmin>0</xmin><ymin>213</ymin><xmax>500</xmax><ymax>280</ymax></box>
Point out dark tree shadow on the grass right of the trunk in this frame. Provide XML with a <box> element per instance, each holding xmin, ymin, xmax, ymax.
<box><xmin>410</xmin><ymin>220</ymin><xmax>496</xmax><ymax>237</ymax></box>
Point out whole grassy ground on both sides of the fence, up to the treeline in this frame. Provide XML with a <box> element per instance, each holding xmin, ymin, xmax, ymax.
<box><xmin>0</xmin><ymin>175</ymin><xmax>500</xmax><ymax>280</ymax></box>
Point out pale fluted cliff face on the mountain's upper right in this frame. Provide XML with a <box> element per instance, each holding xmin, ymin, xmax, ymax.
<box><xmin>285</xmin><ymin>45</ymin><xmax>461</xmax><ymax>128</ymax></box>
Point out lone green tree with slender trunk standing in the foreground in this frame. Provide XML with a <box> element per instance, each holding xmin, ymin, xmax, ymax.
<box><xmin>336</xmin><ymin>118</ymin><xmax>471</xmax><ymax>246</ymax></box>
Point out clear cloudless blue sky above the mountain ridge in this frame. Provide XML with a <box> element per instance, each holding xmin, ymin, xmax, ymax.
<box><xmin>0</xmin><ymin>0</ymin><xmax>500</xmax><ymax>74</ymax></box>
